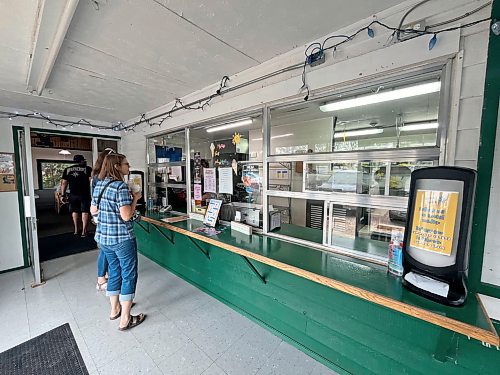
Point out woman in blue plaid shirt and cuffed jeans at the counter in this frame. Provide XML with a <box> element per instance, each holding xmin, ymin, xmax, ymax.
<box><xmin>90</xmin><ymin>154</ymin><xmax>146</xmax><ymax>331</ymax></box>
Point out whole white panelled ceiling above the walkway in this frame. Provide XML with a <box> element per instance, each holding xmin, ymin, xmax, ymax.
<box><xmin>0</xmin><ymin>0</ymin><xmax>401</xmax><ymax>121</ymax></box>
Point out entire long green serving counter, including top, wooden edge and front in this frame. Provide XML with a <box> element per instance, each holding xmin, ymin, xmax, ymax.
<box><xmin>135</xmin><ymin>213</ymin><xmax>500</xmax><ymax>374</ymax></box>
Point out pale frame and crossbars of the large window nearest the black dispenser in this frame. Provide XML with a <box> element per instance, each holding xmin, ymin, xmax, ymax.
<box><xmin>262</xmin><ymin>61</ymin><xmax>452</xmax><ymax>265</ymax></box>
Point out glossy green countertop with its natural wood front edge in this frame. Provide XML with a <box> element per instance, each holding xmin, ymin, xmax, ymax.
<box><xmin>140</xmin><ymin>213</ymin><xmax>500</xmax><ymax>346</ymax></box>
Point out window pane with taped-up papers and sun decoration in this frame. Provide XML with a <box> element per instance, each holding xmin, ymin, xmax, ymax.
<box><xmin>189</xmin><ymin>113</ymin><xmax>264</xmax><ymax>228</ymax></box>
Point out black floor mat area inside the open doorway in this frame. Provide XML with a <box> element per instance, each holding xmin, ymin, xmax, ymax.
<box><xmin>38</xmin><ymin>233</ymin><xmax>97</xmax><ymax>262</ymax></box>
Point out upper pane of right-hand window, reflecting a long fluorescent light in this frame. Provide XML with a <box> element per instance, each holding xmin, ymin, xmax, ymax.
<box><xmin>270</xmin><ymin>72</ymin><xmax>441</xmax><ymax>155</ymax></box>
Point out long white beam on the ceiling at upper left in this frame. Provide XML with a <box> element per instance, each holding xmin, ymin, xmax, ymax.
<box><xmin>28</xmin><ymin>0</ymin><xmax>79</xmax><ymax>95</ymax></box>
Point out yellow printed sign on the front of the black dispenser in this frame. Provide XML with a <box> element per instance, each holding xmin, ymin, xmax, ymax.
<box><xmin>410</xmin><ymin>190</ymin><xmax>459</xmax><ymax>256</ymax></box>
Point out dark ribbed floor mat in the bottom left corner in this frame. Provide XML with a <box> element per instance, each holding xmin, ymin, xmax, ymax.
<box><xmin>0</xmin><ymin>323</ymin><xmax>89</xmax><ymax>375</ymax></box>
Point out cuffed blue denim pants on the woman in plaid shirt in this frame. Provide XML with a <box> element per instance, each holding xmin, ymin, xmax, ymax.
<box><xmin>99</xmin><ymin>238</ymin><xmax>137</xmax><ymax>301</ymax></box>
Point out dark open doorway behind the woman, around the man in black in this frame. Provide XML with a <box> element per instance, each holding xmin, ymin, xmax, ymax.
<box><xmin>30</xmin><ymin>130</ymin><xmax>118</xmax><ymax>262</ymax></box>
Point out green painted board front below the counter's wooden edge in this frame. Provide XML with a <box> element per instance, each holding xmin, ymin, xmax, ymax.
<box><xmin>135</xmin><ymin>217</ymin><xmax>500</xmax><ymax>374</ymax></box>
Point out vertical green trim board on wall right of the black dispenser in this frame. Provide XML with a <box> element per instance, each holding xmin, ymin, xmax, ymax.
<box><xmin>469</xmin><ymin>0</ymin><xmax>500</xmax><ymax>292</ymax></box>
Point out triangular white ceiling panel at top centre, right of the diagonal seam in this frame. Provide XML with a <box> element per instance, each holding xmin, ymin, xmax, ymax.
<box><xmin>154</xmin><ymin>0</ymin><xmax>401</xmax><ymax>62</ymax></box>
